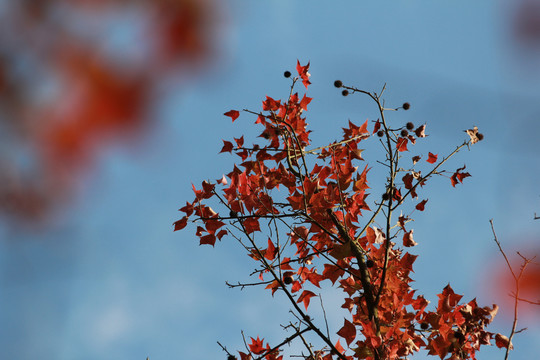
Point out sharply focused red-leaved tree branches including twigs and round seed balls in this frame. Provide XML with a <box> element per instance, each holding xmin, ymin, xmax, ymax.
<box><xmin>174</xmin><ymin>62</ymin><xmax>510</xmax><ymax>360</ymax></box>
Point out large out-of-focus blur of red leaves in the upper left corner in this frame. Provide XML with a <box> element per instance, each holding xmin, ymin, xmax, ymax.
<box><xmin>0</xmin><ymin>0</ymin><xmax>215</xmax><ymax>223</ymax></box>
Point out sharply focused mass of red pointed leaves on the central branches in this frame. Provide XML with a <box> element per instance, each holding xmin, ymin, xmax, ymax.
<box><xmin>174</xmin><ymin>63</ymin><xmax>508</xmax><ymax>360</ymax></box>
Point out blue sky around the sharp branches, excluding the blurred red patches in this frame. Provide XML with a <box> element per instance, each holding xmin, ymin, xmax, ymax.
<box><xmin>0</xmin><ymin>0</ymin><xmax>540</xmax><ymax>360</ymax></box>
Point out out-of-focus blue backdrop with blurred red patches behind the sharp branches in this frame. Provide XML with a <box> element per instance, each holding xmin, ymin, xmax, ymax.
<box><xmin>0</xmin><ymin>0</ymin><xmax>540</xmax><ymax>360</ymax></box>
